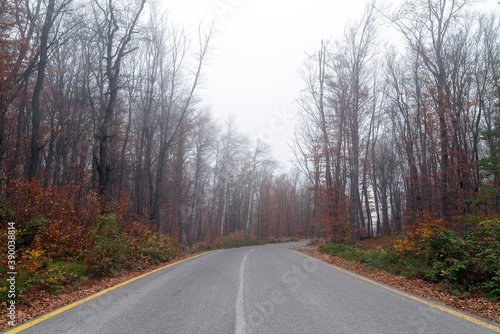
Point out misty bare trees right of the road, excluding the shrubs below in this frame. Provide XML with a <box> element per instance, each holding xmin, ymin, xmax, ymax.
<box><xmin>295</xmin><ymin>0</ymin><xmax>500</xmax><ymax>241</ymax></box>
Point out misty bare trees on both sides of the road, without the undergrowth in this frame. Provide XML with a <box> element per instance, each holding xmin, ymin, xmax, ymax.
<box><xmin>0</xmin><ymin>0</ymin><xmax>500</xmax><ymax>247</ymax></box>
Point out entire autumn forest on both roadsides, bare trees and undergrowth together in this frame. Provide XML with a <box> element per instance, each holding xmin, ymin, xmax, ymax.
<box><xmin>0</xmin><ymin>0</ymin><xmax>500</xmax><ymax>328</ymax></box>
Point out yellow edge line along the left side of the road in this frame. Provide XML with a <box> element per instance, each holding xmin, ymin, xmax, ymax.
<box><xmin>5</xmin><ymin>251</ymin><xmax>213</xmax><ymax>334</ymax></box>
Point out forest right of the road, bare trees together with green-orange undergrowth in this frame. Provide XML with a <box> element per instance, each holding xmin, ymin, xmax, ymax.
<box><xmin>295</xmin><ymin>0</ymin><xmax>500</xmax><ymax>301</ymax></box>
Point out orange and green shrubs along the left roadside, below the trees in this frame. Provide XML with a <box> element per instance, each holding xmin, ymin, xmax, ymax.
<box><xmin>0</xmin><ymin>181</ymin><xmax>180</xmax><ymax>304</ymax></box>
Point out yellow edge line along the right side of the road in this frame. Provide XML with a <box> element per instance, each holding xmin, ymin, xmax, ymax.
<box><xmin>289</xmin><ymin>249</ymin><xmax>500</xmax><ymax>333</ymax></box>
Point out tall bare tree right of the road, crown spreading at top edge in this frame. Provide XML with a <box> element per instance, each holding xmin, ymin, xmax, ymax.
<box><xmin>391</xmin><ymin>0</ymin><xmax>472</xmax><ymax>218</ymax></box>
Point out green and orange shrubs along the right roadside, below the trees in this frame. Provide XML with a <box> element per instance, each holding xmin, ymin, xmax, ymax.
<box><xmin>318</xmin><ymin>216</ymin><xmax>500</xmax><ymax>301</ymax></box>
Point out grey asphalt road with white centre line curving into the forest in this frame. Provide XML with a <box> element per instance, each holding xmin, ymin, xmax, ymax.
<box><xmin>4</xmin><ymin>244</ymin><xmax>500</xmax><ymax>334</ymax></box>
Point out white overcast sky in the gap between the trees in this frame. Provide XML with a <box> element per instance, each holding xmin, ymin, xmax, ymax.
<box><xmin>160</xmin><ymin>0</ymin><xmax>498</xmax><ymax>167</ymax></box>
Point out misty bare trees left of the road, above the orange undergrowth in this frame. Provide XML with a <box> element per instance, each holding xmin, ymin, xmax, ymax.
<box><xmin>0</xmin><ymin>0</ymin><xmax>313</xmax><ymax>247</ymax></box>
